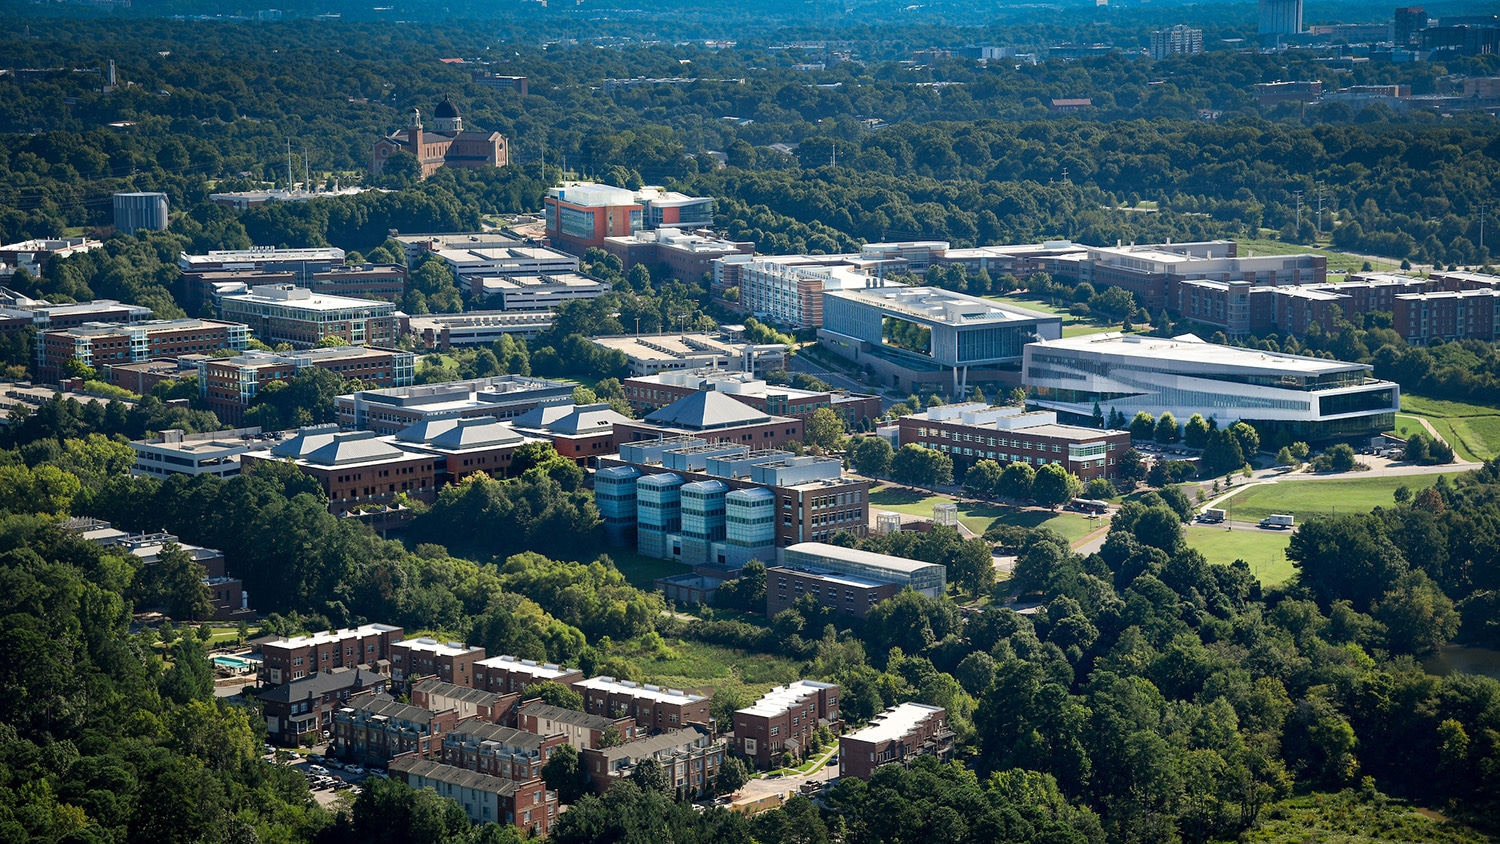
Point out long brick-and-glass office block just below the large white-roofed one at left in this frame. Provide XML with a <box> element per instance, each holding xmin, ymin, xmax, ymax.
<box><xmin>198</xmin><ymin>346</ymin><xmax>417</xmax><ymax>424</ymax></box>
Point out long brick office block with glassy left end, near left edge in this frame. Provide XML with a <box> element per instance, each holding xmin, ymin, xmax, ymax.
<box><xmin>36</xmin><ymin>319</ymin><xmax>251</xmax><ymax>382</ymax></box>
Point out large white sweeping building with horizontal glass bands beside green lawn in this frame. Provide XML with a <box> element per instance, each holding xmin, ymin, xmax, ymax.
<box><xmin>1022</xmin><ymin>333</ymin><xmax>1401</xmax><ymax>445</ymax></box>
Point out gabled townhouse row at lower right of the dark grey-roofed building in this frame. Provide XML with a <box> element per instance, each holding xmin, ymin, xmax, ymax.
<box><xmin>329</xmin><ymin>693</ymin><xmax>459</xmax><ymax>768</ymax></box>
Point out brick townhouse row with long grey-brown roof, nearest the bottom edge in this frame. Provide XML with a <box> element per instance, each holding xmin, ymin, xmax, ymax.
<box><xmin>390</xmin><ymin>756</ymin><xmax>558</xmax><ymax>837</ymax></box>
